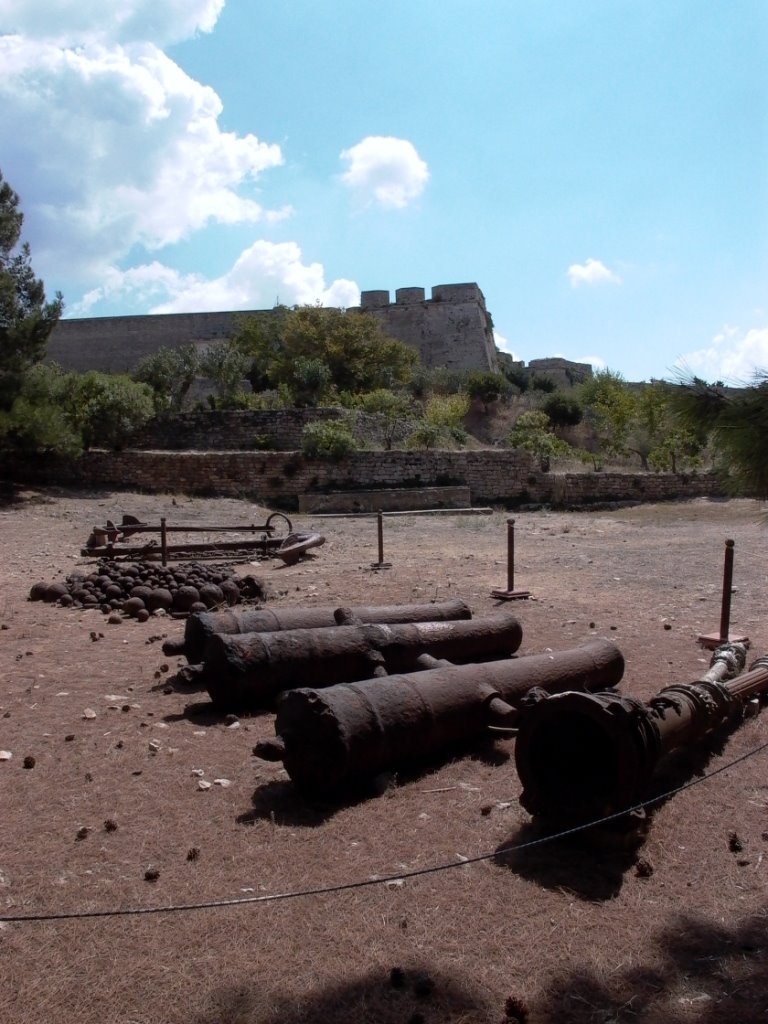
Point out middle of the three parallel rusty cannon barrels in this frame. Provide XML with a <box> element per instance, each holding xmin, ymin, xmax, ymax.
<box><xmin>202</xmin><ymin>614</ymin><xmax>522</xmax><ymax>711</ymax></box>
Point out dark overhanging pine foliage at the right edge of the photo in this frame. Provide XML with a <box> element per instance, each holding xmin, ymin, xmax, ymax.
<box><xmin>671</xmin><ymin>371</ymin><xmax>768</xmax><ymax>501</ymax></box>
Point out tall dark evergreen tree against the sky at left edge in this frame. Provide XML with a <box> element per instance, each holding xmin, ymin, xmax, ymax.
<box><xmin>0</xmin><ymin>168</ymin><xmax>63</xmax><ymax>410</ymax></box>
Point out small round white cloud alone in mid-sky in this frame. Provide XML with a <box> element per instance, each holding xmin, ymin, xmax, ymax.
<box><xmin>340</xmin><ymin>135</ymin><xmax>429</xmax><ymax>208</ymax></box>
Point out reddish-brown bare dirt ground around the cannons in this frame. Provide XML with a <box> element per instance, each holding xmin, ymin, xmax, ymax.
<box><xmin>0</xmin><ymin>490</ymin><xmax>768</xmax><ymax>1024</ymax></box>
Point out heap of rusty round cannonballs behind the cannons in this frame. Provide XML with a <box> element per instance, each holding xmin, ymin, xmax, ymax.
<box><xmin>30</xmin><ymin>558</ymin><xmax>266</xmax><ymax>622</ymax></box>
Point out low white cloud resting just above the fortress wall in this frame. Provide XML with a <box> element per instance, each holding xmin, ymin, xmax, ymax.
<box><xmin>71</xmin><ymin>241</ymin><xmax>360</xmax><ymax>316</ymax></box>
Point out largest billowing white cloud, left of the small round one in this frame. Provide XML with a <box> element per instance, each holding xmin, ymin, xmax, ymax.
<box><xmin>0</xmin><ymin>32</ymin><xmax>283</xmax><ymax>276</ymax></box>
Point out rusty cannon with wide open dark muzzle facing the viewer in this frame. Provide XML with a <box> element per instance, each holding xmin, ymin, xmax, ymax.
<box><xmin>515</xmin><ymin>644</ymin><xmax>768</xmax><ymax>824</ymax></box>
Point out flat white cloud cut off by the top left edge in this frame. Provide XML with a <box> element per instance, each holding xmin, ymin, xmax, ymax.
<box><xmin>0</xmin><ymin>0</ymin><xmax>225</xmax><ymax>46</ymax></box>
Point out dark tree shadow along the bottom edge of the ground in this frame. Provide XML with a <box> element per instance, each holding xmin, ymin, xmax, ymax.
<box><xmin>189</xmin><ymin>907</ymin><xmax>768</xmax><ymax>1024</ymax></box>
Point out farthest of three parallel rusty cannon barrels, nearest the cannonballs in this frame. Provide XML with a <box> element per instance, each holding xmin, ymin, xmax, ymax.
<box><xmin>163</xmin><ymin>599</ymin><xmax>472</xmax><ymax>665</ymax></box>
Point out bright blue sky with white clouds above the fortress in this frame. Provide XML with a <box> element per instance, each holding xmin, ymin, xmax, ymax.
<box><xmin>0</xmin><ymin>0</ymin><xmax>768</xmax><ymax>381</ymax></box>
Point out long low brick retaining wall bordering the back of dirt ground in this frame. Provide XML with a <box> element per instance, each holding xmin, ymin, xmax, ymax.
<box><xmin>0</xmin><ymin>450</ymin><xmax>721</xmax><ymax>509</ymax></box>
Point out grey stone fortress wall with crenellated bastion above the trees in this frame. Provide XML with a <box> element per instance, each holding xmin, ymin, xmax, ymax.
<box><xmin>47</xmin><ymin>284</ymin><xmax>498</xmax><ymax>373</ymax></box>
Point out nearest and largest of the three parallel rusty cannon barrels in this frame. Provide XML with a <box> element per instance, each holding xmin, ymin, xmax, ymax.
<box><xmin>256</xmin><ymin>640</ymin><xmax>624</xmax><ymax>795</ymax></box>
